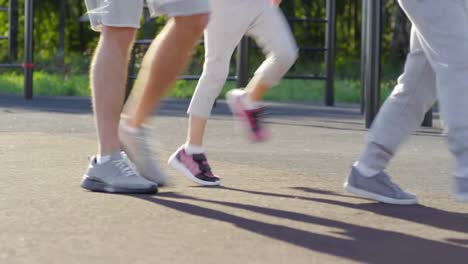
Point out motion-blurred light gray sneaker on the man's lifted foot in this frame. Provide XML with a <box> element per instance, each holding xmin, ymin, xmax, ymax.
<box><xmin>119</xmin><ymin>125</ymin><xmax>169</xmax><ymax>185</ymax></box>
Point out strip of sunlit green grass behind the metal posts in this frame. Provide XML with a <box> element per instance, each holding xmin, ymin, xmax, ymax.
<box><xmin>0</xmin><ymin>72</ymin><xmax>394</xmax><ymax>103</ymax></box>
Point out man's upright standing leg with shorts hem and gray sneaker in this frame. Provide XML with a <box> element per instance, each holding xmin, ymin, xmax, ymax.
<box><xmin>81</xmin><ymin>0</ymin><xmax>157</xmax><ymax>193</ymax></box>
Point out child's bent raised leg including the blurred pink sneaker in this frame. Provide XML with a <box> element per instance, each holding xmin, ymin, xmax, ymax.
<box><xmin>223</xmin><ymin>1</ymin><xmax>297</xmax><ymax>142</ymax></box>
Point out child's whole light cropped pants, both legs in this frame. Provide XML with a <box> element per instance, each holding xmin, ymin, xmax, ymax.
<box><xmin>188</xmin><ymin>0</ymin><xmax>297</xmax><ymax>118</ymax></box>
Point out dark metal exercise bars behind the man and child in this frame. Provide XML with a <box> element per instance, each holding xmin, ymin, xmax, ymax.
<box><xmin>127</xmin><ymin>0</ymin><xmax>336</xmax><ymax>106</ymax></box>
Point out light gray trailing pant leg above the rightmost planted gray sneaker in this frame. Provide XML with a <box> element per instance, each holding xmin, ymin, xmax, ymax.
<box><xmin>359</xmin><ymin>28</ymin><xmax>436</xmax><ymax>171</ymax></box>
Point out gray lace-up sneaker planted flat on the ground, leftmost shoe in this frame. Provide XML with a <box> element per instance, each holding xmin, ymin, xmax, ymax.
<box><xmin>81</xmin><ymin>152</ymin><xmax>158</xmax><ymax>193</ymax></box>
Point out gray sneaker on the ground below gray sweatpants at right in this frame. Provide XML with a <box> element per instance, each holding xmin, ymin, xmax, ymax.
<box><xmin>344</xmin><ymin>167</ymin><xmax>418</xmax><ymax>205</ymax></box>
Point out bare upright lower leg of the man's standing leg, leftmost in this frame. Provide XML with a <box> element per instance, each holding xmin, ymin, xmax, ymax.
<box><xmin>91</xmin><ymin>26</ymin><xmax>136</xmax><ymax>155</ymax></box>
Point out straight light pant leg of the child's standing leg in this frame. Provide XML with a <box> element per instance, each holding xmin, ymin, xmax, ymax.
<box><xmin>187</xmin><ymin>0</ymin><xmax>259</xmax><ymax>118</ymax></box>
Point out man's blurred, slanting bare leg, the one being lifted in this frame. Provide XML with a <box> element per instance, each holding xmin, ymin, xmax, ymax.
<box><xmin>127</xmin><ymin>14</ymin><xmax>208</xmax><ymax>127</ymax></box>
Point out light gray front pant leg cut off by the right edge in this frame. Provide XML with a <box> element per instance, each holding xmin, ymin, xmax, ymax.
<box><xmin>399</xmin><ymin>0</ymin><xmax>468</xmax><ymax>177</ymax></box>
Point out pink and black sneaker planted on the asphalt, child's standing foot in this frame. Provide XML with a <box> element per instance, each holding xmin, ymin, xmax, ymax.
<box><xmin>168</xmin><ymin>146</ymin><xmax>220</xmax><ymax>186</ymax></box>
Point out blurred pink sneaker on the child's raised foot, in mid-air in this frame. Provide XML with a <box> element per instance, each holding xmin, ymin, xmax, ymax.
<box><xmin>226</xmin><ymin>89</ymin><xmax>271</xmax><ymax>142</ymax></box>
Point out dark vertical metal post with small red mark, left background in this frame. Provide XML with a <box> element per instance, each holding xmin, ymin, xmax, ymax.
<box><xmin>23</xmin><ymin>0</ymin><xmax>34</xmax><ymax>99</ymax></box>
